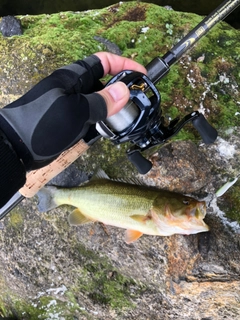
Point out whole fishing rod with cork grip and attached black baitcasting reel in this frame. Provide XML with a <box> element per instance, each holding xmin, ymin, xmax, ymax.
<box><xmin>0</xmin><ymin>0</ymin><xmax>240</xmax><ymax>219</ymax></box>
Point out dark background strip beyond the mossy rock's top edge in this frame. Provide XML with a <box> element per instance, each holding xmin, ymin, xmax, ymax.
<box><xmin>0</xmin><ymin>0</ymin><xmax>240</xmax><ymax>28</ymax></box>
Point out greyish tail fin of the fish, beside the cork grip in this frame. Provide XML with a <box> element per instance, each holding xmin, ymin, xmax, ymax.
<box><xmin>37</xmin><ymin>187</ymin><xmax>58</xmax><ymax>212</ymax></box>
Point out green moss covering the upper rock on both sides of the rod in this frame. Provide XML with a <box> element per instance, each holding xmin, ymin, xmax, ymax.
<box><xmin>0</xmin><ymin>1</ymin><xmax>240</xmax><ymax>129</ymax></box>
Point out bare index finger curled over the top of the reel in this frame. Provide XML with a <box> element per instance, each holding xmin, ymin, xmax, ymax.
<box><xmin>95</xmin><ymin>52</ymin><xmax>147</xmax><ymax>76</ymax></box>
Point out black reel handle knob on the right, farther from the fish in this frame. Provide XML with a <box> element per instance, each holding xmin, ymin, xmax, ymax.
<box><xmin>192</xmin><ymin>113</ymin><xmax>218</xmax><ymax>144</ymax></box>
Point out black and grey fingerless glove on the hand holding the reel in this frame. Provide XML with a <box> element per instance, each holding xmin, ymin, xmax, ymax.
<box><xmin>0</xmin><ymin>55</ymin><xmax>107</xmax><ymax>170</ymax></box>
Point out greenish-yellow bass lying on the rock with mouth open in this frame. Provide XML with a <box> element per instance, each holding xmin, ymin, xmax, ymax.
<box><xmin>37</xmin><ymin>176</ymin><xmax>209</xmax><ymax>244</ymax></box>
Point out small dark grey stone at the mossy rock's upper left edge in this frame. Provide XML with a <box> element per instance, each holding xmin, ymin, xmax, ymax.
<box><xmin>0</xmin><ymin>16</ymin><xmax>22</xmax><ymax>37</ymax></box>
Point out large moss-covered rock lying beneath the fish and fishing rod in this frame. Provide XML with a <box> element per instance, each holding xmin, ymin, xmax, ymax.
<box><xmin>0</xmin><ymin>2</ymin><xmax>240</xmax><ymax>320</ymax></box>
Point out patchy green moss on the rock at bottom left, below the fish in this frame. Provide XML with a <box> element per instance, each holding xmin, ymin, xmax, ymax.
<box><xmin>0</xmin><ymin>244</ymin><xmax>146</xmax><ymax>320</ymax></box>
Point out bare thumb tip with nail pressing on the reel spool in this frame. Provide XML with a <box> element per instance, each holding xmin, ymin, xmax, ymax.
<box><xmin>98</xmin><ymin>81</ymin><xmax>130</xmax><ymax>117</ymax></box>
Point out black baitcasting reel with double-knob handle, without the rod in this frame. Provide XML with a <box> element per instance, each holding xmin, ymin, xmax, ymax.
<box><xmin>96</xmin><ymin>70</ymin><xmax>217</xmax><ymax>174</ymax></box>
